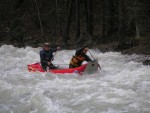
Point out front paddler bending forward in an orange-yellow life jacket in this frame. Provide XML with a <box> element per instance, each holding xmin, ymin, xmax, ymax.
<box><xmin>69</xmin><ymin>46</ymin><xmax>92</xmax><ymax>68</ymax></box>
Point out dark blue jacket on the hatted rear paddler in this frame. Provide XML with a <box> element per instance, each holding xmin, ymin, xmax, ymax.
<box><xmin>40</xmin><ymin>48</ymin><xmax>57</xmax><ymax>69</ymax></box>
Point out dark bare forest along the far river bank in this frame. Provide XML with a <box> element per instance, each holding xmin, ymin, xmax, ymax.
<box><xmin>0</xmin><ymin>0</ymin><xmax>150</xmax><ymax>54</ymax></box>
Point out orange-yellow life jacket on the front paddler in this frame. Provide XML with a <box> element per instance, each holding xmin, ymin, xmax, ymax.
<box><xmin>70</xmin><ymin>55</ymin><xmax>85</xmax><ymax>67</ymax></box>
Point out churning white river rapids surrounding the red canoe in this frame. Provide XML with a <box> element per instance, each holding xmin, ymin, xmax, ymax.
<box><xmin>0</xmin><ymin>45</ymin><xmax>150</xmax><ymax>113</ymax></box>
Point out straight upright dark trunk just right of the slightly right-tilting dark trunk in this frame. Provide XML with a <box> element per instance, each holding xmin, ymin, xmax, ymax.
<box><xmin>76</xmin><ymin>0</ymin><xmax>80</xmax><ymax>40</ymax></box>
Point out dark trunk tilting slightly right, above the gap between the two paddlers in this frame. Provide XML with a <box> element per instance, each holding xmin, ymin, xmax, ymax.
<box><xmin>64</xmin><ymin>0</ymin><xmax>72</xmax><ymax>46</ymax></box>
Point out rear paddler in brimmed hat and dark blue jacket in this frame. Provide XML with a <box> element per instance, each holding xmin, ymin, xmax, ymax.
<box><xmin>40</xmin><ymin>42</ymin><xmax>60</xmax><ymax>70</ymax></box>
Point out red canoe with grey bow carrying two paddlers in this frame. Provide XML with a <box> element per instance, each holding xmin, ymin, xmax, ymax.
<box><xmin>28</xmin><ymin>60</ymin><xmax>98</xmax><ymax>74</ymax></box>
